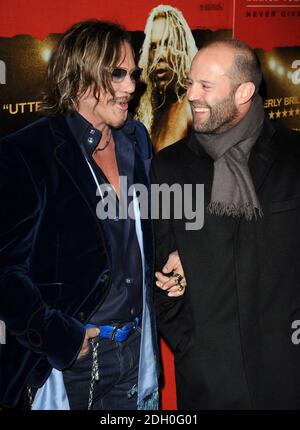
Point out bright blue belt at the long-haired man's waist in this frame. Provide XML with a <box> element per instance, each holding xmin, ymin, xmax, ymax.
<box><xmin>85</xmin><ymin>314</ymin><xmax>142</xmax><ymax>342</ymax></box>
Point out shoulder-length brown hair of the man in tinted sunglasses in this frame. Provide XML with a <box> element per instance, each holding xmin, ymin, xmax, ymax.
<box><xmin>42</xmin><ymin>20</ymin><xmax>130</xmax><ymax>115</ymax></box>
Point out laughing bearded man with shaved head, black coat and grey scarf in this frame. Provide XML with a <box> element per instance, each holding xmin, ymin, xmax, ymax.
<box><xmin>152</xmin><ymin>40</ymin><xmax>300</xmax><ymax>409</ymax></box>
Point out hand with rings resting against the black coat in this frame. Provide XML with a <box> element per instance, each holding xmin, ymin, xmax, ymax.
<box><xmin>155</xmin><ymin>251</ymin><xmax>186</xmax><ymax>297</ymax></box>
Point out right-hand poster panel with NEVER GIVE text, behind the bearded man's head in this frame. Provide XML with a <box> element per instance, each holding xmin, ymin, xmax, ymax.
<box><xmin>233</xmin><ymin>0</ymin><xmax>300</xmax><ymax>130</ymax></box>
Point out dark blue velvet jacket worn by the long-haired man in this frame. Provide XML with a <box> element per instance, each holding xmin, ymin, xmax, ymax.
<box><xmin>0</xmin><ymin>115</ymin><xmax>157</xmax><ymax>406</ymax></box>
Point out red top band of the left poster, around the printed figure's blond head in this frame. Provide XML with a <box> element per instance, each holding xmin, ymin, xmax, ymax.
<box><xmin>0</xmin><ymin>0</ymin><xmax>233</xmax><ymax>39</ymax></box>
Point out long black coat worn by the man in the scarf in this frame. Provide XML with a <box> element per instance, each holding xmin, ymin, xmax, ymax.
<box><xmin>152</xmin><ymin>120</ymin><xmax>300</xmax><ymax>409</ymax></box>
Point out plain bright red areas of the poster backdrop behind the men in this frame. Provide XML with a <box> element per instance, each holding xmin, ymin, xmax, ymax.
<box><xmin>0</xmin><ymin>0</ymin><xmax>300</xmax><ymax>409</ymax></box>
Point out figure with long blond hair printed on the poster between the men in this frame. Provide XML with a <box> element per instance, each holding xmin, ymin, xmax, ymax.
<box><xmin>136</xmin><ymin>5</ymin><xmax>197</xmax><ymax>151</ymax></box>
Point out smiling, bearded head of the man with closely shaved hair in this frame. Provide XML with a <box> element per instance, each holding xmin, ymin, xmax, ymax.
<box><xmin>187</xmin><ymin>40</ymin><xmax>261</xmax><ymax>133</ymax></box>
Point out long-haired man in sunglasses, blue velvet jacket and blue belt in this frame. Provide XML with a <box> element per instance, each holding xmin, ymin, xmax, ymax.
<box><xmin>0</xmin><ymin>20</ymin><xmax>182</xmax><ymax>410</ymax></box>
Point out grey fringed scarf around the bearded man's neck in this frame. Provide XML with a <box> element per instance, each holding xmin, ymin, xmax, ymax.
<box><xmin>195</xmin><ymin>95</ymin><xmax>264</xmax><ymax>220</ymax></box>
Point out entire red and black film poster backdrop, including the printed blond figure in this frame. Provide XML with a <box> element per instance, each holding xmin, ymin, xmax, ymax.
<box><xmin>0</xmin><ymin>0</ymin><xmax>300</xmax><ymax>409</ymax></box>
